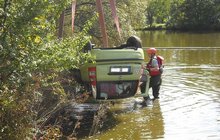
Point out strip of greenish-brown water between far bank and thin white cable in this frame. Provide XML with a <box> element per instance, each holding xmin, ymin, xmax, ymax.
<box><xmin>141</xmin><ymin>31</ymin><xmax>220</xmax><ymax>47</ymax></box>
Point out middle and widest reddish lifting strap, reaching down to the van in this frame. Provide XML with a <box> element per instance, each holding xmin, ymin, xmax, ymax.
<box><xmin>96</xmin><ymin>0</ymin><xmax>108</xmax><ymax>48</ymax></box>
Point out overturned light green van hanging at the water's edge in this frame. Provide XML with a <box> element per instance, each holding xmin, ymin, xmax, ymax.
<box><xmin>73</xmin><ymin>36</ymin><xmax>144</xmax><ymax>100</ymax></box>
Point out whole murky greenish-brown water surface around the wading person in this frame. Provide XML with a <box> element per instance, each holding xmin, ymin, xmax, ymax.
<box><xmin>85</xmin><ymin>32</ymin><xmax>220</xmax><ymax>140</ymax></box>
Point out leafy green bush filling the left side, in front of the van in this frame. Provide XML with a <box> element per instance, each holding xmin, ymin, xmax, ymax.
<box><xmin>0</xmin><ymin>0</ymin><xmax>95</xmax><ymax>140</ymax></box>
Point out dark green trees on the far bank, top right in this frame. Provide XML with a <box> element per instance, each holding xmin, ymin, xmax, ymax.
<box><xmin>146</xmin><ymin>0</ymin><xmax>220</xmax><ymax>30</ymax></box>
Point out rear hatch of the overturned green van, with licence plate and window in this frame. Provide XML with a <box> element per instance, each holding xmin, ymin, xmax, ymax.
<box><xmin>96</xmin><ymin>63</ymin><xmax>141</xmax><ymax>99</ymax></box>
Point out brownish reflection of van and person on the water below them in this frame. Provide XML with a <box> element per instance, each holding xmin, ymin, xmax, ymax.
<box><xmin>90</xmin><ymin>98</ymin><xmax>164</xmax><ymax>140</ymax></box>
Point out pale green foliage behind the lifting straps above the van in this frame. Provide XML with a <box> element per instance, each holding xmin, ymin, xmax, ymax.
<box><xmin>64</xmin><ymin>0</ymin><xmax>146</xmax><ymax>46</ymax></box>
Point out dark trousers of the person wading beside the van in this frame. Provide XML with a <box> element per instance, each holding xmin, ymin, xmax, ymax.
<box><xmin>149</xmin><ymin>75</ymin><xmax>162</xmax><ymax>99</ymax></box>
